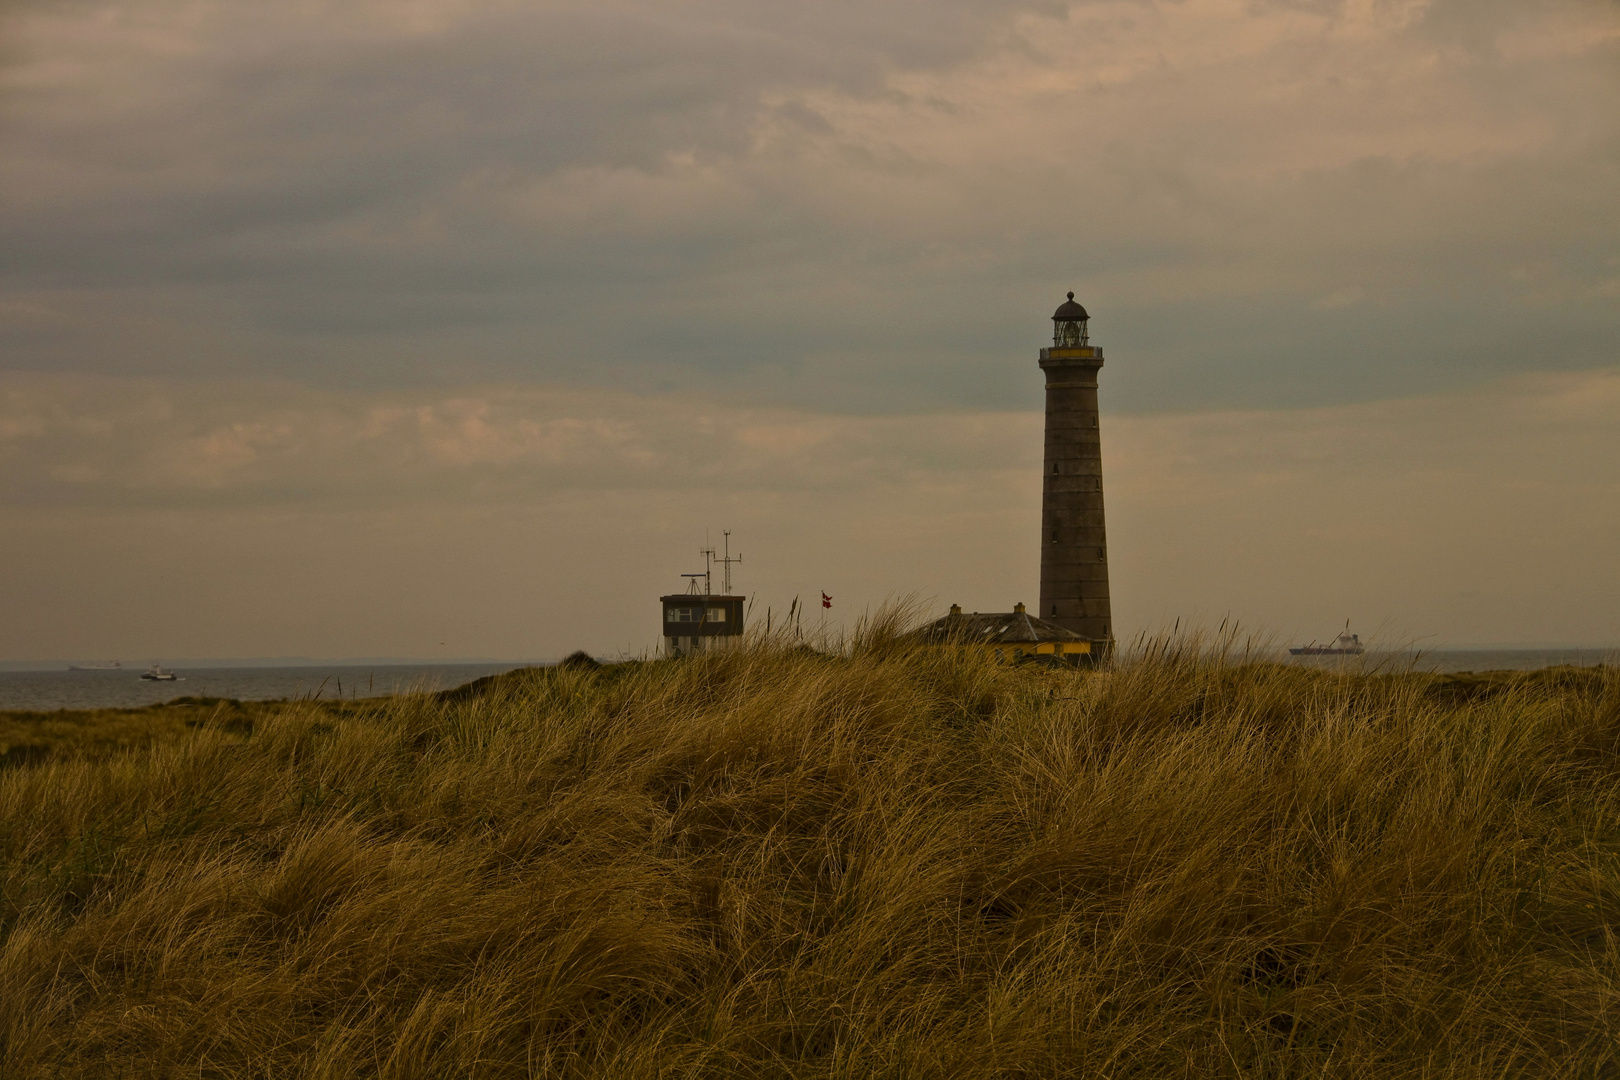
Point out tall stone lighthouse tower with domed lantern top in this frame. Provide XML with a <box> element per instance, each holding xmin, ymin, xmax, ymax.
<box><xmin>1040</xmin><ymin>293</ymin><xmax>1113</xmax><ymax>647</ymax></box>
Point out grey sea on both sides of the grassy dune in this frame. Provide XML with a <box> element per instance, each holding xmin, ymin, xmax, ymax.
<box><xmin>0</xmin><ymin>649</ymin><xmax>1620</xmax><ymax>712</ymax></box>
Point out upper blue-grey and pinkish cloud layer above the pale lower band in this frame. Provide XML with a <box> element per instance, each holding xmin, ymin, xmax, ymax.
<box><xmin>0</xmin><ymin>0</ymin><xmax>1620</xmax><ymax>413</ymax></box>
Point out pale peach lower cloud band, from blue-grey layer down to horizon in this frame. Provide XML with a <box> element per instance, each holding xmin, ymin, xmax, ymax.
<box><xmin>0</xmin><ymin>368</ymin><xmax>1620</xmax><ymax>657</ymax></box>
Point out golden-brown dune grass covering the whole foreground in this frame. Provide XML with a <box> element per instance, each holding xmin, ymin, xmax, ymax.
<box><xmin>0</xmin><ymin>625</ymin><xmax>1620</xmax><ymax>1078</ymax></box>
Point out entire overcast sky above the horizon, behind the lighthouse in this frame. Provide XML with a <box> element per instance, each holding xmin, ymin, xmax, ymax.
<box><xmin>0</xmin><ymin>0</ymin><xmax>1620</xmax><ymax>662</ymax></box>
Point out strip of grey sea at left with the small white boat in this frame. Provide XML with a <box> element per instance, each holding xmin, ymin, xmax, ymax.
<box><xmin>0</xmin><ymin>664</ymin><xmax>523</xmax><ymax>712</ymax></box>
